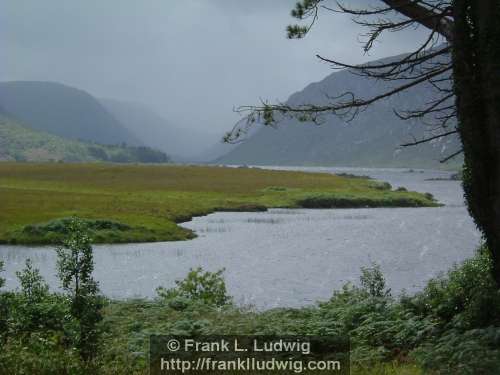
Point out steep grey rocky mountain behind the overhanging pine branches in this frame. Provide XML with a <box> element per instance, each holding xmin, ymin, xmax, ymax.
<box><xmin>214</xmin><ymin>53</ymin><xmax>460</xmax><ymax>167</ymax></box>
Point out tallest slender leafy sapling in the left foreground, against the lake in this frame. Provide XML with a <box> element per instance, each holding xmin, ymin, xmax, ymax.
<box><xmin>56</xmin><ymin>218</ymin><xmax>103</xmax><ymax>362</ymax></box>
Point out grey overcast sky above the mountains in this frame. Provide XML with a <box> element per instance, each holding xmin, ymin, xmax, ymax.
<box><xmin>0</xmin><ymin>0</ymin><xmax>428</xmax><ymax>141</ymax></box>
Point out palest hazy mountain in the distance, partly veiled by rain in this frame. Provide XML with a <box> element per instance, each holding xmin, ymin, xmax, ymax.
<box><xmin>100</xmin><ymin>99</ymin><xmax>223</xmax><ymax>161</ymax></box>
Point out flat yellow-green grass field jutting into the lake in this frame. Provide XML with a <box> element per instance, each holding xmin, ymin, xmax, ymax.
<box><xmin>0</xmin><ymin>162</ymin><xmax>437</xmax><ymax>244</ymax></box>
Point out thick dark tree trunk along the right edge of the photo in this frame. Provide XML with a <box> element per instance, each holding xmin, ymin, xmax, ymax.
<box><xmin>453</xmin><ymin>0</ymin><xmax>500</xmax><ymax>287</ymax></box>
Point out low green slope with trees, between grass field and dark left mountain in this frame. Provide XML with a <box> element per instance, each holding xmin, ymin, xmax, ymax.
<box><xmin>0</xmin><ymin>115</ymin><xmax>168</xmax><ymax>163</ymax></box>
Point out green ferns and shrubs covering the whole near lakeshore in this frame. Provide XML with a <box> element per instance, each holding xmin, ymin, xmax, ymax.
<box><xmin>0</xmin><ymin>219</ymin><xmax>500</xmax><ymax>375</ymax></box>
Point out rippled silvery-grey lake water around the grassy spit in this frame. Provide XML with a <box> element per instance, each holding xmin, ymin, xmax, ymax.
<box><xmin>0</xmin><ymin>168</ymin><xmax>480</xmax><ymax>308</ymax></box>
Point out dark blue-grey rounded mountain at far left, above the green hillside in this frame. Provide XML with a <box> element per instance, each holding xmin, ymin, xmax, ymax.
<box><xmin>0</xmin><ymin>81</ymin><xmax>141</xmax><ymax>145</ymax></box>
